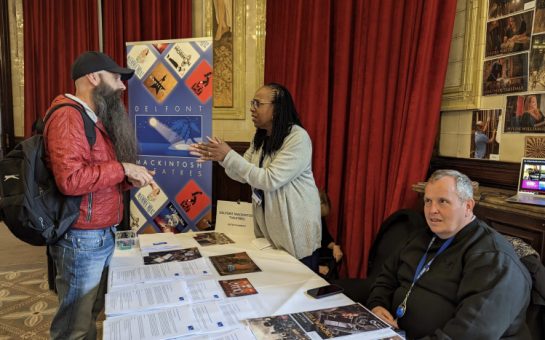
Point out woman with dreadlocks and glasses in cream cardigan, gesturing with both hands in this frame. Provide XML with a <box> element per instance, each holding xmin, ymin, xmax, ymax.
<box><xmin>191</xmin><ymin>83</ymin><xmax>321</xmax><ymax>272</ymax></box>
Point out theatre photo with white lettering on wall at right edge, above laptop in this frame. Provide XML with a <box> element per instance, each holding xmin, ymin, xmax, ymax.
<box><xmin>504</xmin><ymin>94</ymin><xmax>545</xmax><ymax>133</ymax></box>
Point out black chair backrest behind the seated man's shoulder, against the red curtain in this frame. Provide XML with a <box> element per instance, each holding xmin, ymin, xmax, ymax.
<box><xmin>367</xmin><ymin>209</ymin><xmax>427</xmax><ymax>280</ymax></box>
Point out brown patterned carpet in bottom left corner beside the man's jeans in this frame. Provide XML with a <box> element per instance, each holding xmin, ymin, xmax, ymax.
<box><xmin>0</xmin><ymin>264</ymin><xmax>58</xmax><ymax>340</ymax></box>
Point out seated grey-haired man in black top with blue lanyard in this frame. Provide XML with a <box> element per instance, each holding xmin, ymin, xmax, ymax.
<box><xmin>367</xmin><ymin>170</ymin><xmax>532</xmax><ymax>339</ymax></box>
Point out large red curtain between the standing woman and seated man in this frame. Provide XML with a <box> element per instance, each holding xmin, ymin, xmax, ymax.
<box><xmin>265</xmin><ymin>0</ymin><xmax>456</xmax><ymax>277</ymax></box>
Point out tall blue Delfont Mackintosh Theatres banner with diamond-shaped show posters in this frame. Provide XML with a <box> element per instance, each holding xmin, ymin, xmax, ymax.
<box><xmin>127</xmin><ymin>38</ymin><xmax>213</xmax><ymax>234</ymax></box>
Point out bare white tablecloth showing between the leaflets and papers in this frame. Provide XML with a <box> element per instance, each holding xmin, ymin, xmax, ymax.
<box><xmin>111</xmin><ymin>233</ymin><xmax>354</xmax><ymax>317</ymax></box>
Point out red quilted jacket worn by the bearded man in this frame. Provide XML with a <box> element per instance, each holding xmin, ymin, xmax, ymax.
<box><xmin>44</xmin><ymin>95</ymin><xmax>128</xmax><ymax>229</ymax></box>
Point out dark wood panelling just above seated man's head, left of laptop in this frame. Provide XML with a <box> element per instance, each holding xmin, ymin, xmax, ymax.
<box><xmin>428</xmin><ymin>157</ymin><xmax>520</xmax><ymax>190</ymax></box>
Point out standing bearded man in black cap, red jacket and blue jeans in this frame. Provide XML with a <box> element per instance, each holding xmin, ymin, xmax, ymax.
<box><xmin>44</xmin><ymin>52</ymin><xmax>155</xmax><ymax>339</ymax></box>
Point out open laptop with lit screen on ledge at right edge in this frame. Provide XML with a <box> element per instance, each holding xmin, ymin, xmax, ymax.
<box><xmin>506</xmin><ymin>158</ymin><xmax>545</xmax><ymax>207</ymax></box>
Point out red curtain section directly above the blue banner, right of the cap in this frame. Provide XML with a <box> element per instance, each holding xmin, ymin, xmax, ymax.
<box><xmin>102</xmin><ymin>0</ymin><xmax>192</xmax><ymax>71</ymax></box>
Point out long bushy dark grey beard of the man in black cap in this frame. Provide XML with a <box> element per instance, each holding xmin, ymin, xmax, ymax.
<box><xmin>93</xmin><ymin>81</ymin><xmax>137</xmax><ymax>163</ymax></box>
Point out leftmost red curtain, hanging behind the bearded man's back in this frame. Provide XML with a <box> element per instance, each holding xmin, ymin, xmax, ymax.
<box><xmin>23</xmin><ymin>0</ymin><xmax>98</xmax><ymax>137</ymax></box>
